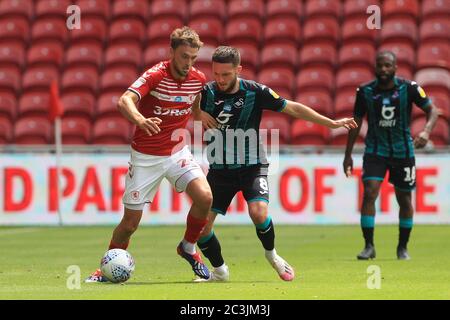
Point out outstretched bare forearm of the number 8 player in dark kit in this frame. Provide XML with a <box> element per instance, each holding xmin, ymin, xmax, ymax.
<box><xmin>283</xmin><ymin>100</ymin><xmax>357</xmax><ymax>130</ymax></box>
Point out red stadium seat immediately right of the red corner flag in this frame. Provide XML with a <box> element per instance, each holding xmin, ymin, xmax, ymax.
<box><xmin>61</xmin><ymin>91</ymin><xmax>96</xmax><ymax>121</ymax></box>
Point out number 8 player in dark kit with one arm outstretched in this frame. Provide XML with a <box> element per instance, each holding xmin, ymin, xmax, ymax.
<box><xmin>193</xmin><ymin>47</ymin><xmax>356</xmax><ymax>281</ymax></box>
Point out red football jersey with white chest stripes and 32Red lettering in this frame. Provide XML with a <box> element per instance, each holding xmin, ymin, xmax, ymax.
<box><xmin>128</xmin><ymin>61</ymin><xmax>206</xmax><ymax>156</ymax></box>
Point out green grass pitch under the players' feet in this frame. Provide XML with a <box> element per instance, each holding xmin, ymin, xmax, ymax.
<box><xmin>0</xmin><ymin>225</ymin><xmax>450</xmax><ymax>300</ymax></box>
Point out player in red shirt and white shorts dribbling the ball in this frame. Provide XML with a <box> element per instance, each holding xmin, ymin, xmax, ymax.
<box><xmin>86</xmin><ymin>27</ymin><xmax>212</xmax><ymax>282</ymax></box>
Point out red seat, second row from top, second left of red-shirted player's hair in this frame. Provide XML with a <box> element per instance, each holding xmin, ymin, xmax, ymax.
<box><xmin>109</xmin><ymin>19</ymin><xmax>145</xmax><ymax>45</ymax></box>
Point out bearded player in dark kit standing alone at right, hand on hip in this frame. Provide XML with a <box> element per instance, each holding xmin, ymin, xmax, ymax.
<box><xmin>343</xmin><ymin>51</ymin><xmax>439</xmax><ymax>260</ymax></box>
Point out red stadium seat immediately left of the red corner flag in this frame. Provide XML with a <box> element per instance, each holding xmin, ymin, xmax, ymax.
<box><xmin>19</xmin><ymin>90</ymin><xmax>50</xmax><ymax>117</ymax></box>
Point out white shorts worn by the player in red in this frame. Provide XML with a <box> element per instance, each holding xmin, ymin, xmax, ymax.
<box><xmin>122</xmin><ymin>146</ymin><xmax>205</xmax><ymax>210</ymax></box>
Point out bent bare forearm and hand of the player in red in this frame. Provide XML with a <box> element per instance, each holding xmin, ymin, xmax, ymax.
<box><xmin>117</xmin><ymin>91</ymin><xmax>161</xmax><ymax>136</ymax></box>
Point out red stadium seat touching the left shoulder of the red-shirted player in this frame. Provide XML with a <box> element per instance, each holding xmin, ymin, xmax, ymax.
<box><xmin>100</xmin><ymin>67</ymin><xmax>139</xmax><ymax>92</ymax></box>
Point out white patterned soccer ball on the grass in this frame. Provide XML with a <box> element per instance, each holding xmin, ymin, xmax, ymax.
<box><xmin>100</xmin><ymin>249</ymin><xmax>134</xmax><ymax>283</ymax></box>
